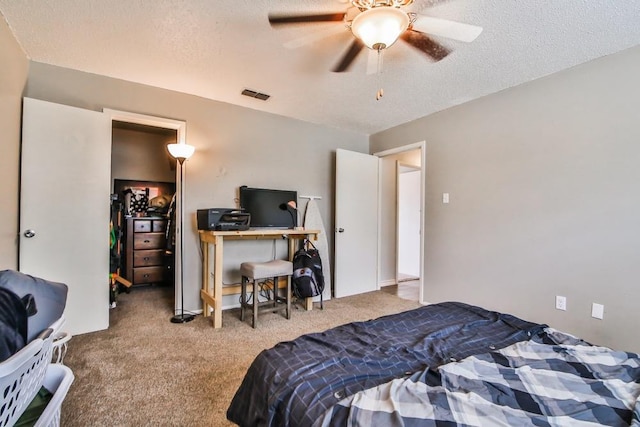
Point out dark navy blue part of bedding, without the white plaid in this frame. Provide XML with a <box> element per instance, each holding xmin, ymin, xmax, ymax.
<box><xmin>227</xmin><ymin>302</ymin><xmax>546</xmax><ymax>427</ymax></box>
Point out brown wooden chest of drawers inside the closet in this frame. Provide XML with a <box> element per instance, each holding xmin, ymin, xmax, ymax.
<box><xmin>124</xmin><ymin>217</ymin><xmax>173</xmax><ymax>285</ymax></box>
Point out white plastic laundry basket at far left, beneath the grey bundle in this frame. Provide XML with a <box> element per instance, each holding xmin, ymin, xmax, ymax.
<box><xmin>0</xmin><ymin>318</ymin><xmax>64</xmax><ymax>427</ymax></box>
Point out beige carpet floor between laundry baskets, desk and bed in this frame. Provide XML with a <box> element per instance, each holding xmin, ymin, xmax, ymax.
<box><xmin>61</xmin><ymin>287</ymin><xmax>419</xmax><ymax>427</ymax></box>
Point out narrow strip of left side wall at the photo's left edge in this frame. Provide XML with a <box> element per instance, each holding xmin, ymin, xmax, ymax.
<box><xmin>0</xmin><ymin>15</ymin><xmax>29</xmax><ymax>270</ymax></box>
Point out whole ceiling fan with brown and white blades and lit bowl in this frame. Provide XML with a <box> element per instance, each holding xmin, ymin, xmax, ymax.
<box><xmin>269</xmin><ymin>0</ymin><xmax>482</xmax><ymax>74</ymax></box>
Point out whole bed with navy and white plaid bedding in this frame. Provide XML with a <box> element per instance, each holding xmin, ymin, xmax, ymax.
<box><xmin>227</xmin><ymin>302</ymin><xmax>640</xmax><ymax>427</ymax></box>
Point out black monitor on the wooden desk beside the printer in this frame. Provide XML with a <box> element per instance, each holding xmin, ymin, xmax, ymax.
<box><xmin>240</xmin><ymin>186</ymin><xmax>298</xmax><ymax>228</ymax></box>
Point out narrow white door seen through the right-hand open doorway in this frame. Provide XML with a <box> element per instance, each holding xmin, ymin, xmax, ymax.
<box><xmin>397</xmin><ymin>169</ymin><xmax>422</xmax><ymax>280</ymax></box>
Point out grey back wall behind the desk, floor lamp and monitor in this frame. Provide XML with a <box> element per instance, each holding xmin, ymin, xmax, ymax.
<box><xmin>26</xmin><ymin>62</ymin><xmax>369</xmax><ymax>310</ymax></box>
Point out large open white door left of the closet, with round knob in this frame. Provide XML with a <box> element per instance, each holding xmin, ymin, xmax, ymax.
<box><xmin>19</xmin><ymin>98</ymin><xmax>111</xmax><ymax>334</ymax></box>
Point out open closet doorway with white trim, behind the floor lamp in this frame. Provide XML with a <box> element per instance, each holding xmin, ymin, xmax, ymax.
<box><xmin>104</xmin><ymin>109</ymin><xmax>186</xmax><ymax>310</ymax></box>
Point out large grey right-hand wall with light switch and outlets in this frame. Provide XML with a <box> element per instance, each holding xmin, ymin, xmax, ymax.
<box><xmin>371</xmin><ymin>47</ymin><xmax>640</xmax><ymax>352</ymax></box>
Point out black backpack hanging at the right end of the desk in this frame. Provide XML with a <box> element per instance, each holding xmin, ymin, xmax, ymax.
<box><xmin>291</xmin><ymin>239</ymin><xmax>324</xmax><ymax>308</ymax></box>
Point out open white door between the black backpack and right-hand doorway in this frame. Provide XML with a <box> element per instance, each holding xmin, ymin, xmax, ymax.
<box><xmin>334</xmin><ymin>150</ymin><xmax>379</xmax><ymax>298</ymax></box>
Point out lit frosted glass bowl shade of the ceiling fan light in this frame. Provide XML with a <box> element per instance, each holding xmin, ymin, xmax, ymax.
<box><xmin>351</xmin><ymin>6</ymin><xmax>409</xmax><ymax>50</ymax></box>
